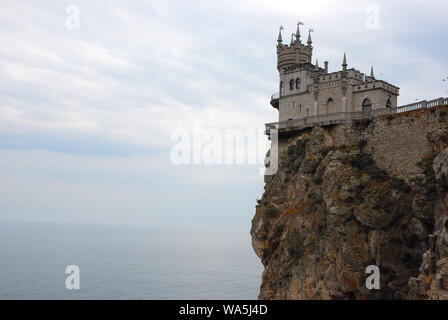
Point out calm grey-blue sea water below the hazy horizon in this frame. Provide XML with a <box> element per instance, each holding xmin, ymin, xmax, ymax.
<box><xmin>0</xmin><ymin>223</ymin><xmax>262</xmax><ymax>299</ymax></box>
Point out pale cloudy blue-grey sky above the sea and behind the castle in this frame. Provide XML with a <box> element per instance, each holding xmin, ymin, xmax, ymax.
<box><xmin>0</xmin><ymin>0</ymin><xmax>448</xmax><ymax>230</ymax></box>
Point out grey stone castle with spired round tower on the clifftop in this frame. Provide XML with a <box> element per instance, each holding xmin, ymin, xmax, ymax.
<box><xmin>271</xmin><ymin>22</ymin><xmax>399</xmax><ymax>123</ymax></box>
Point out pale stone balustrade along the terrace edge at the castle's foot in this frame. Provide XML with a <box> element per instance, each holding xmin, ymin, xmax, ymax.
<box><xmin>266</xmin><ymin>95</ymin><xmax>448</xmax><ymax>132</ymax></box>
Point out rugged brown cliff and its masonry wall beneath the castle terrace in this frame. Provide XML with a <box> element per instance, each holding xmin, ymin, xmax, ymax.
<box><xmin>251</xmin><ymin>107</ymin><xmax>448</xmax><ymax>299</ymax></box>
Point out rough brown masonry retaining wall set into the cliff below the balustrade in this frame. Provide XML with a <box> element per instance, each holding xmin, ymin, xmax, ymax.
<box><xmin>318</xmin><ymin>107</ymin><xmax>447</xmax><ymax>181</ymax></box>
